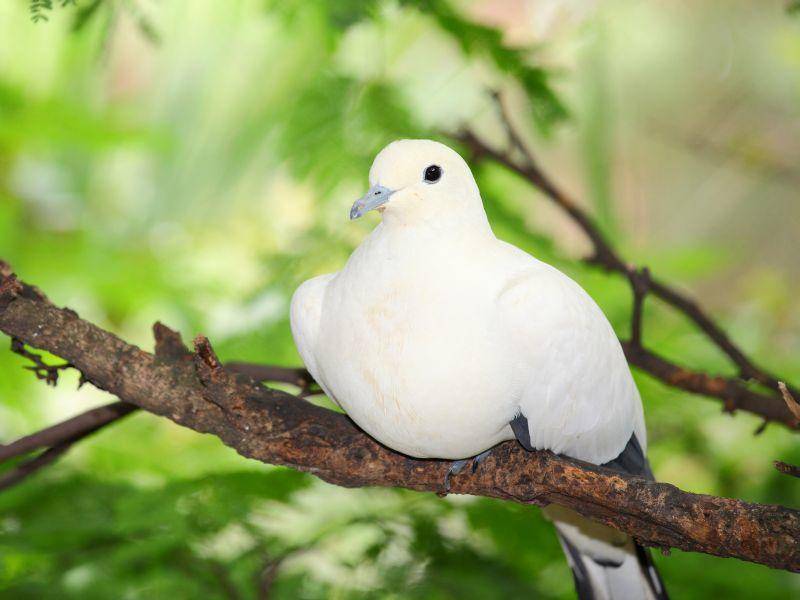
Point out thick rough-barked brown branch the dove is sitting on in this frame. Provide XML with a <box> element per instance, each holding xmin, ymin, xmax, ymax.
<box><xmin>0</xmin><ymin>270</ymin><xmax>800</xmax><ymax>571</ymax></box>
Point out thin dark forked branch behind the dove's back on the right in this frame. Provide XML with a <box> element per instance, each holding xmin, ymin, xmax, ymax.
<box><xmin>454</xmin><ymin>101</ymin><xmax>800</xmax><ymax>429</ymax></box>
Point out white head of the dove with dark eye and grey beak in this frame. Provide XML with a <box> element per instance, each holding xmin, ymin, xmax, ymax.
<box><xmin>350</xmin><ymin>140</ymin><xmax>486</xmax><ymax>226</ymax></box>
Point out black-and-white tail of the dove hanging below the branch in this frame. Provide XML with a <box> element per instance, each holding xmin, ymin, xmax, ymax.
<box><xmin>547</xmin><ymin>507</ymin><xmax>669</xmax><ymax>600</ymax></box>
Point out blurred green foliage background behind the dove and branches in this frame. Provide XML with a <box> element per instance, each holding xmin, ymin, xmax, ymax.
<box><xmin>0</xmin><ymin>0</ymin><xmax>800</xmax><ymax>599</ymax></box>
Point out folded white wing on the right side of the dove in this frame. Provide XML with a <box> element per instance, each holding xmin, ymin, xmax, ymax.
<box><xmin>498</xmin><ymin>249</ymin><xmax>647</xmax><ymax>464</ymax></box>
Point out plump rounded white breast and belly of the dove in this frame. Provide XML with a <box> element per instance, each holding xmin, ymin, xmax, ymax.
<box><xmin>319</xmin><ymin>244</ymin><xmax>521</xmax><ymax>459</ymax></box>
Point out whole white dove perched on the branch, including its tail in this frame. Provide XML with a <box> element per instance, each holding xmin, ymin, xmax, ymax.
<box><xmin>291</xmin><ymin>140</ymin><xmax>667</xmax><ymax>600</ymax></box>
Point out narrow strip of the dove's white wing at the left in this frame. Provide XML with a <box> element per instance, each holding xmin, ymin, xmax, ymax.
<box><xmin>289</xmin><ymin>273</ymin><xmax>336</xmax><ymax>400</ymax></box>
